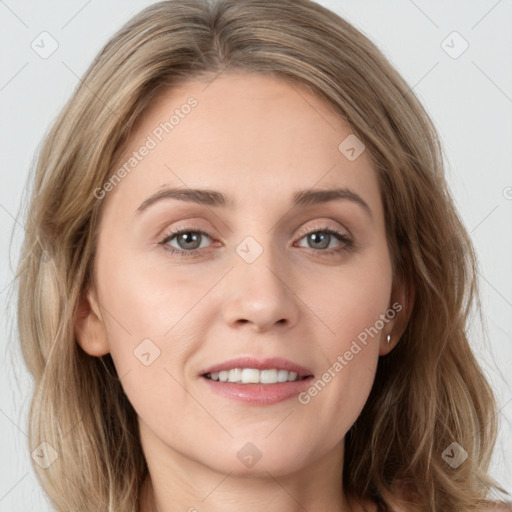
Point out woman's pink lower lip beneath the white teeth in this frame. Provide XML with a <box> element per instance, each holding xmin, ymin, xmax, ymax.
<box><xmin>201</xmin><ymin>376</ymin><xmax>313</xmax><ymax>405</ymax></box>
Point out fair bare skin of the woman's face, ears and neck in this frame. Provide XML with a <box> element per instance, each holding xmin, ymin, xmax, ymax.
<box><xmin>76</xmin><ymin>73</ymin><xmax>410</xmax><ymax>512</ymax></box>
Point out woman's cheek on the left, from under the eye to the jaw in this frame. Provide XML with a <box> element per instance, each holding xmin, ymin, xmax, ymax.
<box><xmin>93</xmin><ymin>244</ymin><xmax>218</xmax><ymax>435</ymax></box>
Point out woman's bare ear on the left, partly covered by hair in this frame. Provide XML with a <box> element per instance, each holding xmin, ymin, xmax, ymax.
<box><xmin>75</xmin><ymin>286</ymin><xmax>110</xmax><ymax>357</ymax></box>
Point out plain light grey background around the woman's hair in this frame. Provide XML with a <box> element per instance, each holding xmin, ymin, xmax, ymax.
<box><xmin>0</xmin><ymin>0</ymin><xmax>512</xmax><ymax>512</ymax></box>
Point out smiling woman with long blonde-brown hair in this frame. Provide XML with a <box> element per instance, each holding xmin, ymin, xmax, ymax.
<box><xmin>15</xmin><ymin>0</ymin><xmax>507</xmax><ymax>512</ymax></box>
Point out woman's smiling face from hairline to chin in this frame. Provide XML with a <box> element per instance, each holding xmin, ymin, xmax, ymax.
<box><xmin>77</xmin><ymin>73</ymin><xmax>401</xmax><ymax>476</ymax></box>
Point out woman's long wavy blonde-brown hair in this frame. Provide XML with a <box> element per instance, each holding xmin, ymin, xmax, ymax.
<box><xmin>18</xmin><ymin>0</ymin><xmax>503</xmax><ymax>512</ymax></box>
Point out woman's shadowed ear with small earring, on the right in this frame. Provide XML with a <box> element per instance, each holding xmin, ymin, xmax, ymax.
<box><xmin>379</xmin><ymin>248</ymin><xmax>416</xmax><ymax>356</ymax></box>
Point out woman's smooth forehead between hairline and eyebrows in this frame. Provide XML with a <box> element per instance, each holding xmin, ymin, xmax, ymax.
<box><xmin>107</xmin><ymin>73</ymin><xmax>381</xmax><ymax>222</ymax></box>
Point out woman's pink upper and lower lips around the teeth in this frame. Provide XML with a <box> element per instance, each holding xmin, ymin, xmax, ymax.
<box><xmin>200</xmin><ymin>357</ymin><xmax>314</xmax><ymax>405</ymax></box>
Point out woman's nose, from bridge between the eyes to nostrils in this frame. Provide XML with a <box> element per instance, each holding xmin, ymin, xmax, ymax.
<box><xmin>224</xmin><ymin>233</ymin><xmax>298</xmax><ymax>329</ymax></box>
